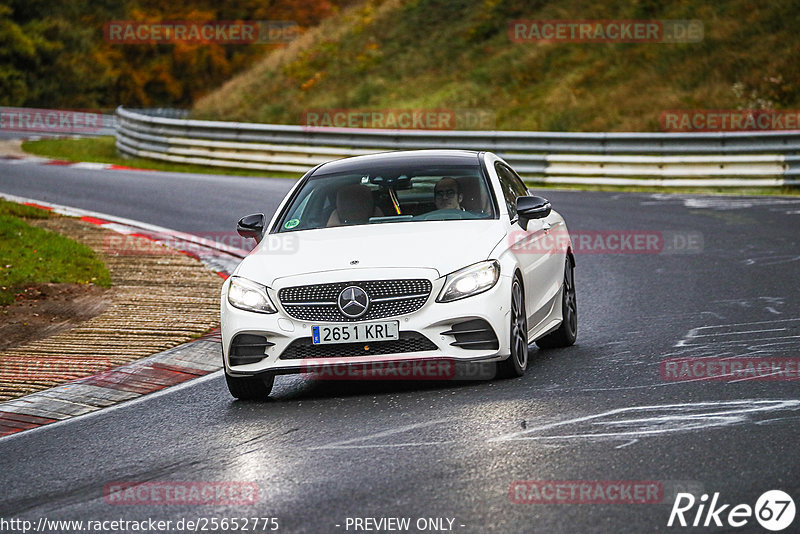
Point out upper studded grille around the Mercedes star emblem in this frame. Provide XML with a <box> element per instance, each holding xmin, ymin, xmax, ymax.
<box><xmin>278</xmin><ymin>278</ymin><xmax>433</xmax><ymax>322</ymax></box>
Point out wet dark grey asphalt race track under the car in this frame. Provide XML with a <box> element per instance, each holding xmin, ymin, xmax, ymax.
<box><xmin>0</xmin><ymin>162</ymin><xmax>800</xmax><ymax>533</ymax></box>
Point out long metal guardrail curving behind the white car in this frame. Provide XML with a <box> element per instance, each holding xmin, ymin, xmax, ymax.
<box><xmin>116</xmin><ymin>107</ymin><xmax>800</xmax><ymax>187</ymax></box>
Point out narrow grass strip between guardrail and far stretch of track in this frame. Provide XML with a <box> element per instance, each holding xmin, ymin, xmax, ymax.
<box><xmin>22</xmin><ymin>137</ymin><xmax>301</xmax><ymax>178</ymax></box>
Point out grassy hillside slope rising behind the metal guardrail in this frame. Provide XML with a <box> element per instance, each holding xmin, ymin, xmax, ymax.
<box><xmin>194</xmin><ymin>0</ymin><xmax>800</xmax><ymax>131</ymax></box>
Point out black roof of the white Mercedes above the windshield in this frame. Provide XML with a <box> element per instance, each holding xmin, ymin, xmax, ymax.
<box><xmin>313</xmin><ymin>150</ymin><xmax>480</xmax><ymax>175</ymax></box>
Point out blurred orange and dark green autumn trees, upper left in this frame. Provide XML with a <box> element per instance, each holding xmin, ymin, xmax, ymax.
<box><xmin>0</xmin><ymin>0</ymin><xmax>343</xmax><ymax>109</ymax></box>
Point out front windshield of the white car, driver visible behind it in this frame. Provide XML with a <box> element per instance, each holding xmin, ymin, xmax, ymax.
<box><xmin>278</xmin><ymin>165</ymin><xmax>495</xmax><ymax>232</ymax></box>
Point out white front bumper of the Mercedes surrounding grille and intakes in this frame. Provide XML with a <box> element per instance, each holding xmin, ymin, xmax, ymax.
<box><xmin>220</xmin><ymin>269</ymin><xmax>511</xmax><ymax>376</ymax></box>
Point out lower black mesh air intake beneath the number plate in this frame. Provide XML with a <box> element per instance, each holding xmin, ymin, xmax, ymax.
<box><xmin>280</xmin><ymin>332</ymin><xmax>437</xmax><ymax>360</ymax></box>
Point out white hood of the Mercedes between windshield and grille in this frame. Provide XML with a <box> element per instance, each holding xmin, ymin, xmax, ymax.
<box><xmin>235</xmin><ymin>219</ymin><xmax>505</xmax><ymax>286</ymax></box>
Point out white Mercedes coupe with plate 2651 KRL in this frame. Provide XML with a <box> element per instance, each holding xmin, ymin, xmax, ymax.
<box><xmin>221</xmin><ymin>150</ymin><xmax>578</xmax><ymax>399</ymax></box>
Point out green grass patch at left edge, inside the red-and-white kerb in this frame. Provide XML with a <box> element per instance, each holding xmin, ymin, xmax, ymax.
<box><xmin>0</xmin><ymin>199</ymin><xmax>111</xmax><ymax>306</ymax></box>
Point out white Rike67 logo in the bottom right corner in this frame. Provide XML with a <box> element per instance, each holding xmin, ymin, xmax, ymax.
<box><xmin>667</xmin><ymin>490</ymin><xmax>795</xmax><ymax>532</ymax></box>
